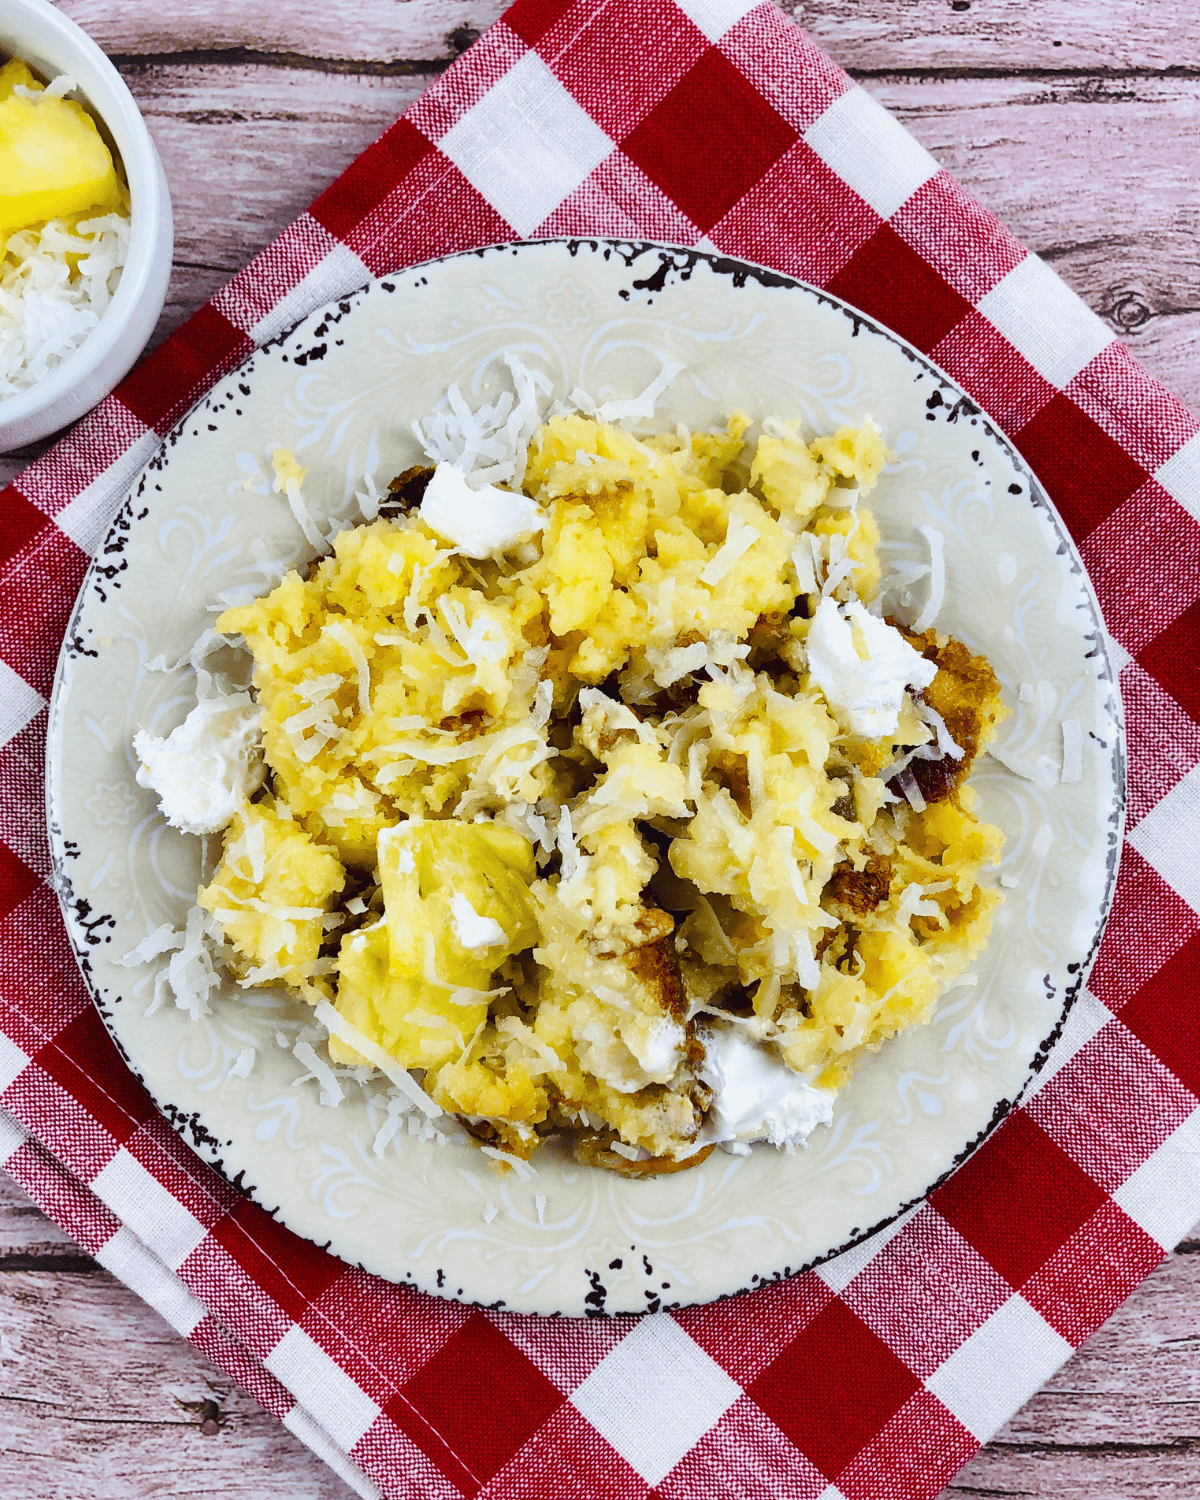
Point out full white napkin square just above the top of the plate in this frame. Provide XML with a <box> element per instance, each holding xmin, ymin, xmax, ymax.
<box><xmin>438</xmin><ymin>53</ymin><xmax>612</xmax><ymax>236</ymax></box>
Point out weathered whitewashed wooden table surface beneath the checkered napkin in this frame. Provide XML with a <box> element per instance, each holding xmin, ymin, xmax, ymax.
<box><xmin>0</xmin><ymin>0</ymin><xmax>1200</xmax><ymax>1500</ymax></box>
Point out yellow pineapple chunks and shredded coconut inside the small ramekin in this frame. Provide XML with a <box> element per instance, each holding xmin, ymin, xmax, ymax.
<box><xmin>0</xmin><ymin>57</ymin><xmax>129</xmax><ymax>401</ymax></box>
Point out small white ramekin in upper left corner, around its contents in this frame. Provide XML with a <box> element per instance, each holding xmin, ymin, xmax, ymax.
<box><xmin>0</xmin><ymin>0</ymin><xmax>174</xmax><ymax>453</ymax></box>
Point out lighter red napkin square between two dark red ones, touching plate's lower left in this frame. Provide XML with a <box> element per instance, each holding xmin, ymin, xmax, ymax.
<box><xmin>303</xmin><ymin>1268</ymin><xmax>471</xmax><ymax>1407</ymax></box>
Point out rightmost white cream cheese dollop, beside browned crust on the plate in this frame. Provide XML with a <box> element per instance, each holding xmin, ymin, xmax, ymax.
<box><xmin>804</xmin><ymin>597</ymin><xmax>938</xmax><ymax>740</ymax></box>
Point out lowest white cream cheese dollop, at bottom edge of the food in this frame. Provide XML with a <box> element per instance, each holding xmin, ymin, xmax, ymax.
<box><xmin>699</xmin><ymin>1023</ymin><xmax>834</xmax><ymax>1148</ymax></box>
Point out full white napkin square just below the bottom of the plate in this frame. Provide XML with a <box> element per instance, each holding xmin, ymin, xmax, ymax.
<box><xmin>572</xmin><ymin>1313</ymin><xmax>741</xmax><ymax>1485</ymax></box>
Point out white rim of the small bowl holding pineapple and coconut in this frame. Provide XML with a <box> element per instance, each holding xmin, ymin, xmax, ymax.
<box><xmin>0</xmin><ymin>0</ymin><xmax>165</xmax><ymax>431</ymax></box>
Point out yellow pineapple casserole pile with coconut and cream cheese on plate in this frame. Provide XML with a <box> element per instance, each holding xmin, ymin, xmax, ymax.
<box><xmin>131</xmin><ymin>362</ymin><xmax>1007</xmax><ymax>1175</ymax></box>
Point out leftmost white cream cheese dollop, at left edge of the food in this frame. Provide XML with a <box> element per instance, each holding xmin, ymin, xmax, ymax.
<box><xmin>134</xmin><ymin>693</ymin><xmax>266</xmax><ymax>834</ymax></box>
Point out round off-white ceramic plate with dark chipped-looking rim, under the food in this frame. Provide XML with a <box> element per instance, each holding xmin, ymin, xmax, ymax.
<box><xmin>48</xmin><ymin>242</ymin><xmax>1122</xmax><ymax>1314</ymax></box>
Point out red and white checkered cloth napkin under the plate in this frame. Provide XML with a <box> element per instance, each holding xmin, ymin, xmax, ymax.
<box><xmin>0</xmin><ymin>0</ymin><xmax>1200</xmax><ymax>1500</ymax></box>
